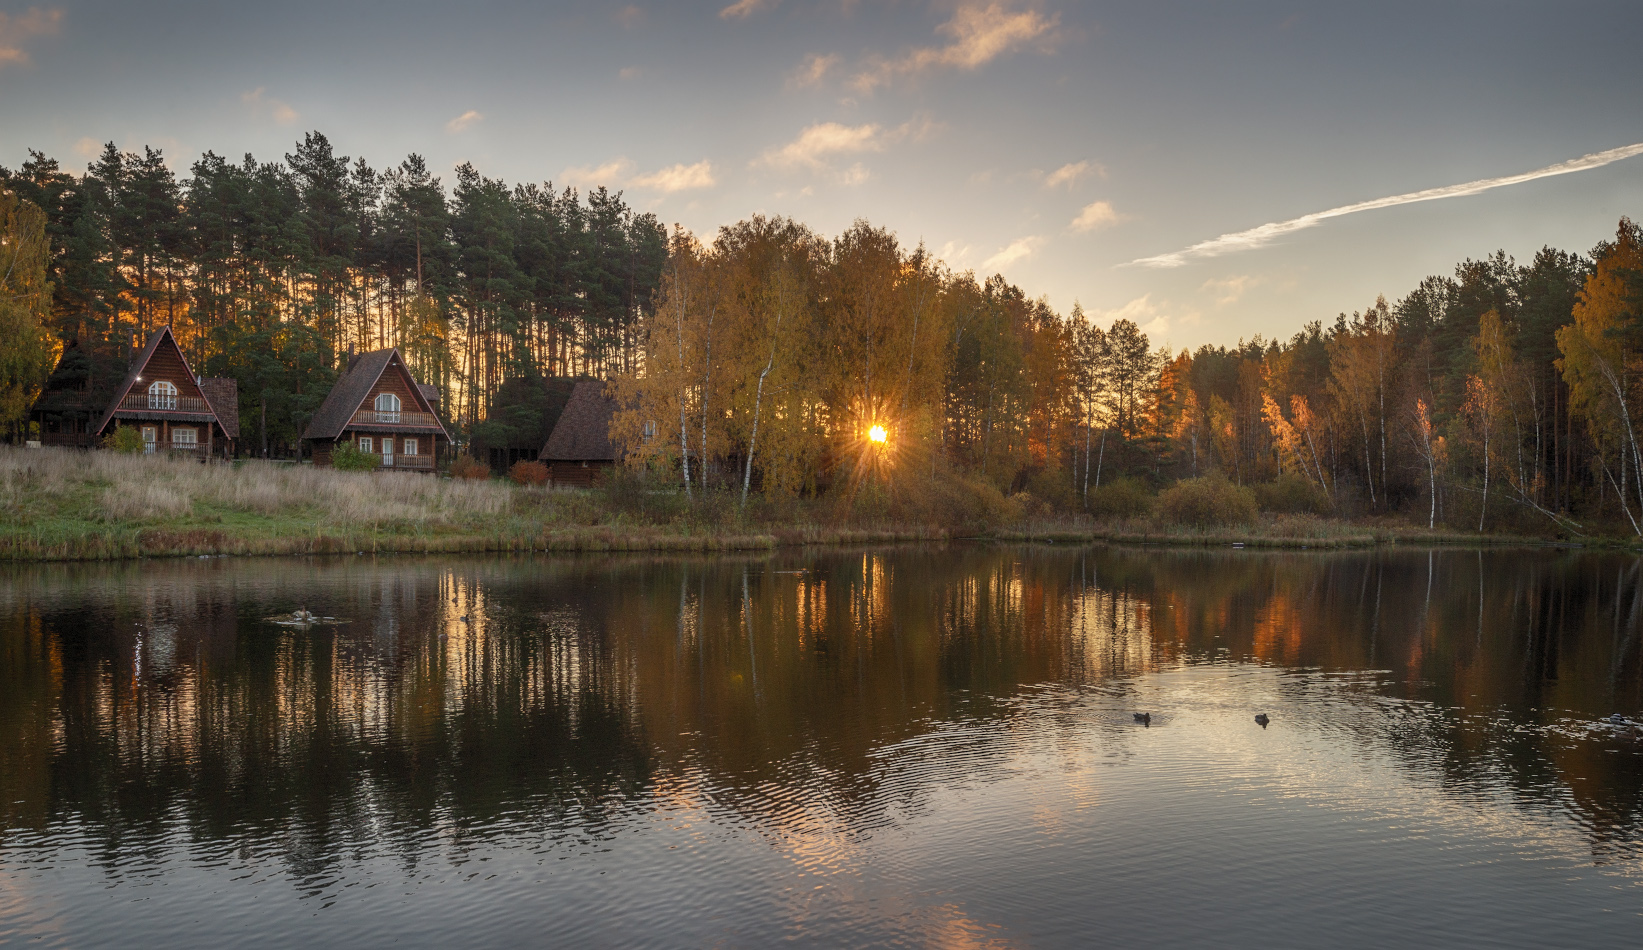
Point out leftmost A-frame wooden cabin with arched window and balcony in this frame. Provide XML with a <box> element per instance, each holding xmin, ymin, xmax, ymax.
<box><xmin>43</xmin><ymin>327</ymin><xmax>240</xmax><ymax>459</ymax></box>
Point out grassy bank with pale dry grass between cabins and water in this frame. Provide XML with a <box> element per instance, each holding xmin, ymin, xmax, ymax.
<box><xmin>0</xmin><ymin>447</ymin><xmax>1557</xmax><ymax>560</ymax></box>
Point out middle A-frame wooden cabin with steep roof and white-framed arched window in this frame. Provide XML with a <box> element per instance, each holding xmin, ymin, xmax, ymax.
<box><xmin>302</xmin><ymin>347</ymin><xmax>450</xmax><ymax>472</ymax></box>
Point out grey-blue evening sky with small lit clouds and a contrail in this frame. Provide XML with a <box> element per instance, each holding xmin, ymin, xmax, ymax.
<box><xmin>0</xmin><ymin>0</ymin><xmax>1643</xmax><ymax>348</ymax></box>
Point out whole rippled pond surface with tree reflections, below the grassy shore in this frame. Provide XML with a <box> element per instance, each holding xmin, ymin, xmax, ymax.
<box><xmin>0</xmin><ymin>546</ymin><xmax>1643</xmax><ymax>947</ymax></box>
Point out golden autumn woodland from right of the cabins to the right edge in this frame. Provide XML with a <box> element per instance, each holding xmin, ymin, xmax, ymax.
<box><xmin>613</xmin><ymin>217</ymin><xmax>1643</xmax><ymax>536</ymax></box>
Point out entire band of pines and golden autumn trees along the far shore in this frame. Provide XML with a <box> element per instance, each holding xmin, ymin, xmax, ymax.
<box><xmin>0</xmin><ymin>133</ymin><xmax>1643</xmax><ymax>536</ymax></box>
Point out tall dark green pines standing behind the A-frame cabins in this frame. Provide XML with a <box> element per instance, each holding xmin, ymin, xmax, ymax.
<box><xmin>0</xmin><ymin>133</ymin><xmax>667</xmax><ymax>445</ymax></box>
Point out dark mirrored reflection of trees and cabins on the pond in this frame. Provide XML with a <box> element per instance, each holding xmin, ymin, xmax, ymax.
<box><xmin>0</xmin><ymin>546</ymin><xmax>1643</xmax><ymax>869</ymax></box>
